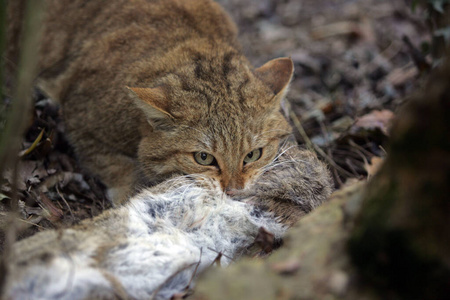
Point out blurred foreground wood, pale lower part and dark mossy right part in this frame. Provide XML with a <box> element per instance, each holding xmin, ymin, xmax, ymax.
<box><xmin>194</xmin><ymin>55</ymin><xmax>450</xmax><ymax>299</ymax></box>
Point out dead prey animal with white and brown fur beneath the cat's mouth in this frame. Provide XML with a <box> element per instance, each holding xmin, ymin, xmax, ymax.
<box><xmin>2</xmin><ymin>147</ymin><xmax>331</xmax><ymax>300</ymax></box>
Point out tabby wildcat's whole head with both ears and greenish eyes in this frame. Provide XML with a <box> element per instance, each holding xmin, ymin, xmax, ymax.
<box><xmin>130</xmin><ymin>55</ymin><xmax>293</xmax><ymax>191</ymax></box>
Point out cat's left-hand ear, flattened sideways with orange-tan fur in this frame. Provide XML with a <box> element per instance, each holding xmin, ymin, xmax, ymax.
<box><xmin>127</xmin><ymin>87</ymin><xmax>175</xmax><ymax>129</ymax></box>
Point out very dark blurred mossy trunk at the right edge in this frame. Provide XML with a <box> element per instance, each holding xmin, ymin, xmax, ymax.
<box><xmin>350</xmin><ymin>52</ymin><xmax>450</xmax><ymax>299</ymax></box>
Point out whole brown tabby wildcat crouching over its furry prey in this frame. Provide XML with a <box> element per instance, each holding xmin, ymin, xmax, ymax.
<box><xmin>6</xmin><ymin>0</ymin><xmax>293</xmax><ymax>203</ymax></box>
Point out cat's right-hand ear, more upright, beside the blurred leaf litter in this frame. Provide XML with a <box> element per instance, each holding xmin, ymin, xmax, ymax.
<box><xmin>255</xmin><ymin>57</ymin><xmax>294</xmax><ymax>95</ymax></box>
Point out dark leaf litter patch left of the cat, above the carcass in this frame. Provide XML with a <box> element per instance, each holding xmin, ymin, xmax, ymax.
<box><xmin>0</xmin><ymin>92</ymin><xmax>111</xmax><ymax>249</ymax></box>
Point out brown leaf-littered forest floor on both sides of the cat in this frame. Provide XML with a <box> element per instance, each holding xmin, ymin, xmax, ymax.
<box><xmin>0</xmin><ymin>0</ymin><xmax>431</xmax><ymax>246</ymax></box>
